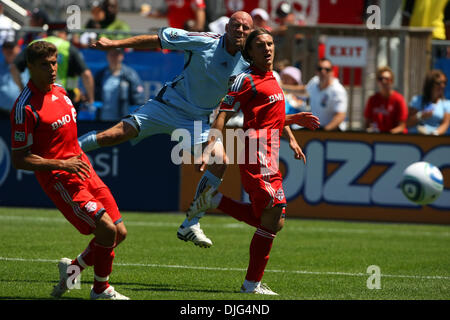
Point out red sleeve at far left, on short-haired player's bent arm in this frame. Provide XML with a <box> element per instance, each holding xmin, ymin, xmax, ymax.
<box><xmin>10</xmin><ymin>104</ymin><xmax>39</xmax><ymax>150</ymax></box>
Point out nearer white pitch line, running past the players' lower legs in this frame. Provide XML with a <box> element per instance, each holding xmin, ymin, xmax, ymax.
<box><xmin>0</xmin><ymin>257</ymin><xmax>450</xmax><ymax>280</ymax></box>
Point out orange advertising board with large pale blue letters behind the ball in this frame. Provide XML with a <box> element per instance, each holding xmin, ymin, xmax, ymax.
<box><xmin>180</xmin><ymin>130</ymin><xmax>450</xmax><ymax>224</ymax></box>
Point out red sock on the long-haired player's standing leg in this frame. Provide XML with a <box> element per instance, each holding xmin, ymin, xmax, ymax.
<box><xmin>245</xmin><ymin>226</ymin><xmax>275</xmax><ymax>281</ymax></box>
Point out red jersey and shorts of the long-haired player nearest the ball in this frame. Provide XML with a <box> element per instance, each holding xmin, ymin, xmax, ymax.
<box><xmin>220</xmin><ymin>67</ymin><xmax>286</xmax><ymax>208</ymax></box>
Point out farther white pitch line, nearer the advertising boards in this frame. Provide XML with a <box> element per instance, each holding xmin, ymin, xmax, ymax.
<box><xmin>0</xmin><ymin>215</ymin><xmax>450</xmax><ymax>238</ymax></box>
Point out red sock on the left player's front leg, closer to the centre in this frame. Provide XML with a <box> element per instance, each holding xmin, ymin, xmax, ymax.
<box><xmin>94</xmin><ymin>242</ymin><xmax>115</xmax><ymax>293</ymax></box>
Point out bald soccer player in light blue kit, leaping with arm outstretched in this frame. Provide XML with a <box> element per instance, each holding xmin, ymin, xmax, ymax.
<box><xmin>78</xmin><ymin>11</ymin><xmax>253</xmax><ymax>247</ymax></box>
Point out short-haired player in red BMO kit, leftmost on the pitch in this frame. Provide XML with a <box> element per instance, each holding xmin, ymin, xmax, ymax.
<box><xmin>11</xmin><ymin>41</ymin><xmax>128</xmax><ymax>300</ymax></box>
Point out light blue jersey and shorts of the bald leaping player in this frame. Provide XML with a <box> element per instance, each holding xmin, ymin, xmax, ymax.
<box><xmin>123</xmin><ymin>28</ymin><xmax>249</xmax><ymax>149</ymax></box>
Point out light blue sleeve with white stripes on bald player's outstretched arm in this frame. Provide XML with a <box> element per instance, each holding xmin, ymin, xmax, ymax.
<box><xmin>158</xmin><ymin>28</ymin><xmax>220</xmax><ymax>51</ymax></box>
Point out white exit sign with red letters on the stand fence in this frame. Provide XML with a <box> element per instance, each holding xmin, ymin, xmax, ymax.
<box><xmin>325</xmin><ymin>37</ymin><xmax>368</xmax><ymax>67</ymax></box>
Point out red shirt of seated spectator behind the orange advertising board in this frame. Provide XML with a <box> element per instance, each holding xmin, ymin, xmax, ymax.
<box><xmin>364</xmin><ymin>91</ymin><xmax>408</xmax><ymax>133</ymax></box>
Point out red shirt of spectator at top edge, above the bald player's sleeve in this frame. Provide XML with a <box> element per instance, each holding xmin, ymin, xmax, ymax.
<box><xmin>166</xmin><ymin>0</ymin><xmax>206</xmax><ymax>29</ymax></box>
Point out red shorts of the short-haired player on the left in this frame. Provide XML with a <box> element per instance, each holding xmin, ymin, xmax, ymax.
<box><xmin>44</xmin><ymin>171</ymin><xmax>122</xmax><ymax>235</ymax></box>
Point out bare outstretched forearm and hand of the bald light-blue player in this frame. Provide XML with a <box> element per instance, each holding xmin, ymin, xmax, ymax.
<box><xmin>91</xmin><ymin>34</ymin><xmax>161</xmax><ymax>50</ymax></box>
